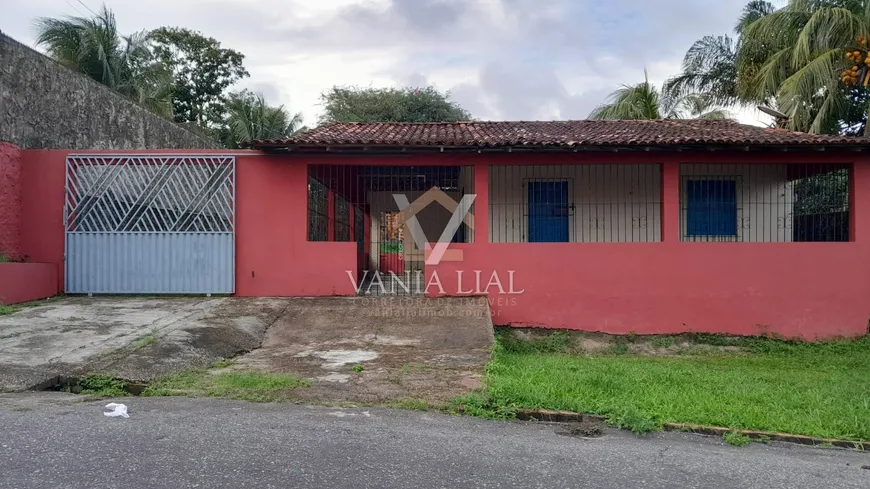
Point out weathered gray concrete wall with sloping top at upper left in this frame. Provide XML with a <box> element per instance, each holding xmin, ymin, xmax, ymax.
<box><xmin>0</xmin><ymin>33</ymin><xmax>219</xmax><ymax>149</ymax></box>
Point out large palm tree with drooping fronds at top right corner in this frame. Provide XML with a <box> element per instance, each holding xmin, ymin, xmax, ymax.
<box><xmin>745</xmin><ymin>0</ymin><xmax>870</xmax><ymax>136</ymax></box>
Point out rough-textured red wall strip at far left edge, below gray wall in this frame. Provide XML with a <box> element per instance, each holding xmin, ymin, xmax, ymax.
<box><xmin>0</xmin><ymin>141</ymin><xmax>23</xmax><ymax>260</ymax></box>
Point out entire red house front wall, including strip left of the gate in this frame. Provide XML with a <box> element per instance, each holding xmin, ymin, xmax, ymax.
<box><xmin>11</xmin><ymin>151</ymin><xmax>870</xmax><ymax>339</ymax></box>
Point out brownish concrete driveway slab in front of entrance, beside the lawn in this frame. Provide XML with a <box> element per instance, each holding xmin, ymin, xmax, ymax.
<box><xmin>235</xmin><ymin>297</ymin><xmax>493</xmax><ymax>403</ymax></box>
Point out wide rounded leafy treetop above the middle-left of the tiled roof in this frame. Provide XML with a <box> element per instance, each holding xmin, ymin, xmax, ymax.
<box><xmin>320</xmin><ymin>87</ymin><xmax>471</xmax><ymax>123</ymax></box>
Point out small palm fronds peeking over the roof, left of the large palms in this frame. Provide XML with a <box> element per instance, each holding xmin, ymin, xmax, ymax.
<box><xmin>589</xmin><ymin>71</ymin><xmax>729</xmax><ymax>119</ymax></box>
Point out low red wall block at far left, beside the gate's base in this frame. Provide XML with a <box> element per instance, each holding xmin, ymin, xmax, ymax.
<box><xmin>0</xmin><ymin>263</ymin><xmax>57</xmax><ymax>304</ymax></box>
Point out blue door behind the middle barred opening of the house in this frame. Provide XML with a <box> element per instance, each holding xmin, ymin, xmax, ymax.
<box><xmin>529</xmin><ymin>180</ymin><xmax>568</xmax><ymax>243</ymax></box>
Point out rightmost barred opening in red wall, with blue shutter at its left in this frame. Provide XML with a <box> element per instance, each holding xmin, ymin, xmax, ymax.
<box><xmin>680</xmin><ymin>164</ymin><xmax>850</xmax><ymax>242</ymax></box>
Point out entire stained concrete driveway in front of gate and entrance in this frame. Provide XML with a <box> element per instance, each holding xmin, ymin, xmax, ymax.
<box><xmin>0</xmin><ymin>297</ymin><xmax>493</xmax><ymax>403</ymax></box>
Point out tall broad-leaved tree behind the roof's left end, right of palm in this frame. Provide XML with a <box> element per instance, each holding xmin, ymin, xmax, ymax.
<box><xmin>151</xmin><ymin>27</ymin><xmax>249</xmax><ymax>128</ymax></box>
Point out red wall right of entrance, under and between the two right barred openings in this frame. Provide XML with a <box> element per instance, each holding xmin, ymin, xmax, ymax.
<box><xmin>426</xmin><ymin>161</ymin><xmax>870</xmax><ymax>339</ymax></box>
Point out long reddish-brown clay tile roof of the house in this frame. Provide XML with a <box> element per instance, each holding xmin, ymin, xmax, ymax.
<box><xmin>249</xmin><ymin>119</ymin><xmax>870</xmax><ymax>149</ymax></box>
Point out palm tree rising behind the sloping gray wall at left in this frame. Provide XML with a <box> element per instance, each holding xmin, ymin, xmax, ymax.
<box><xmin>36</xmin><ymin>5</ymin><xmax>172</xmax><ymax>116</ymax></box>
